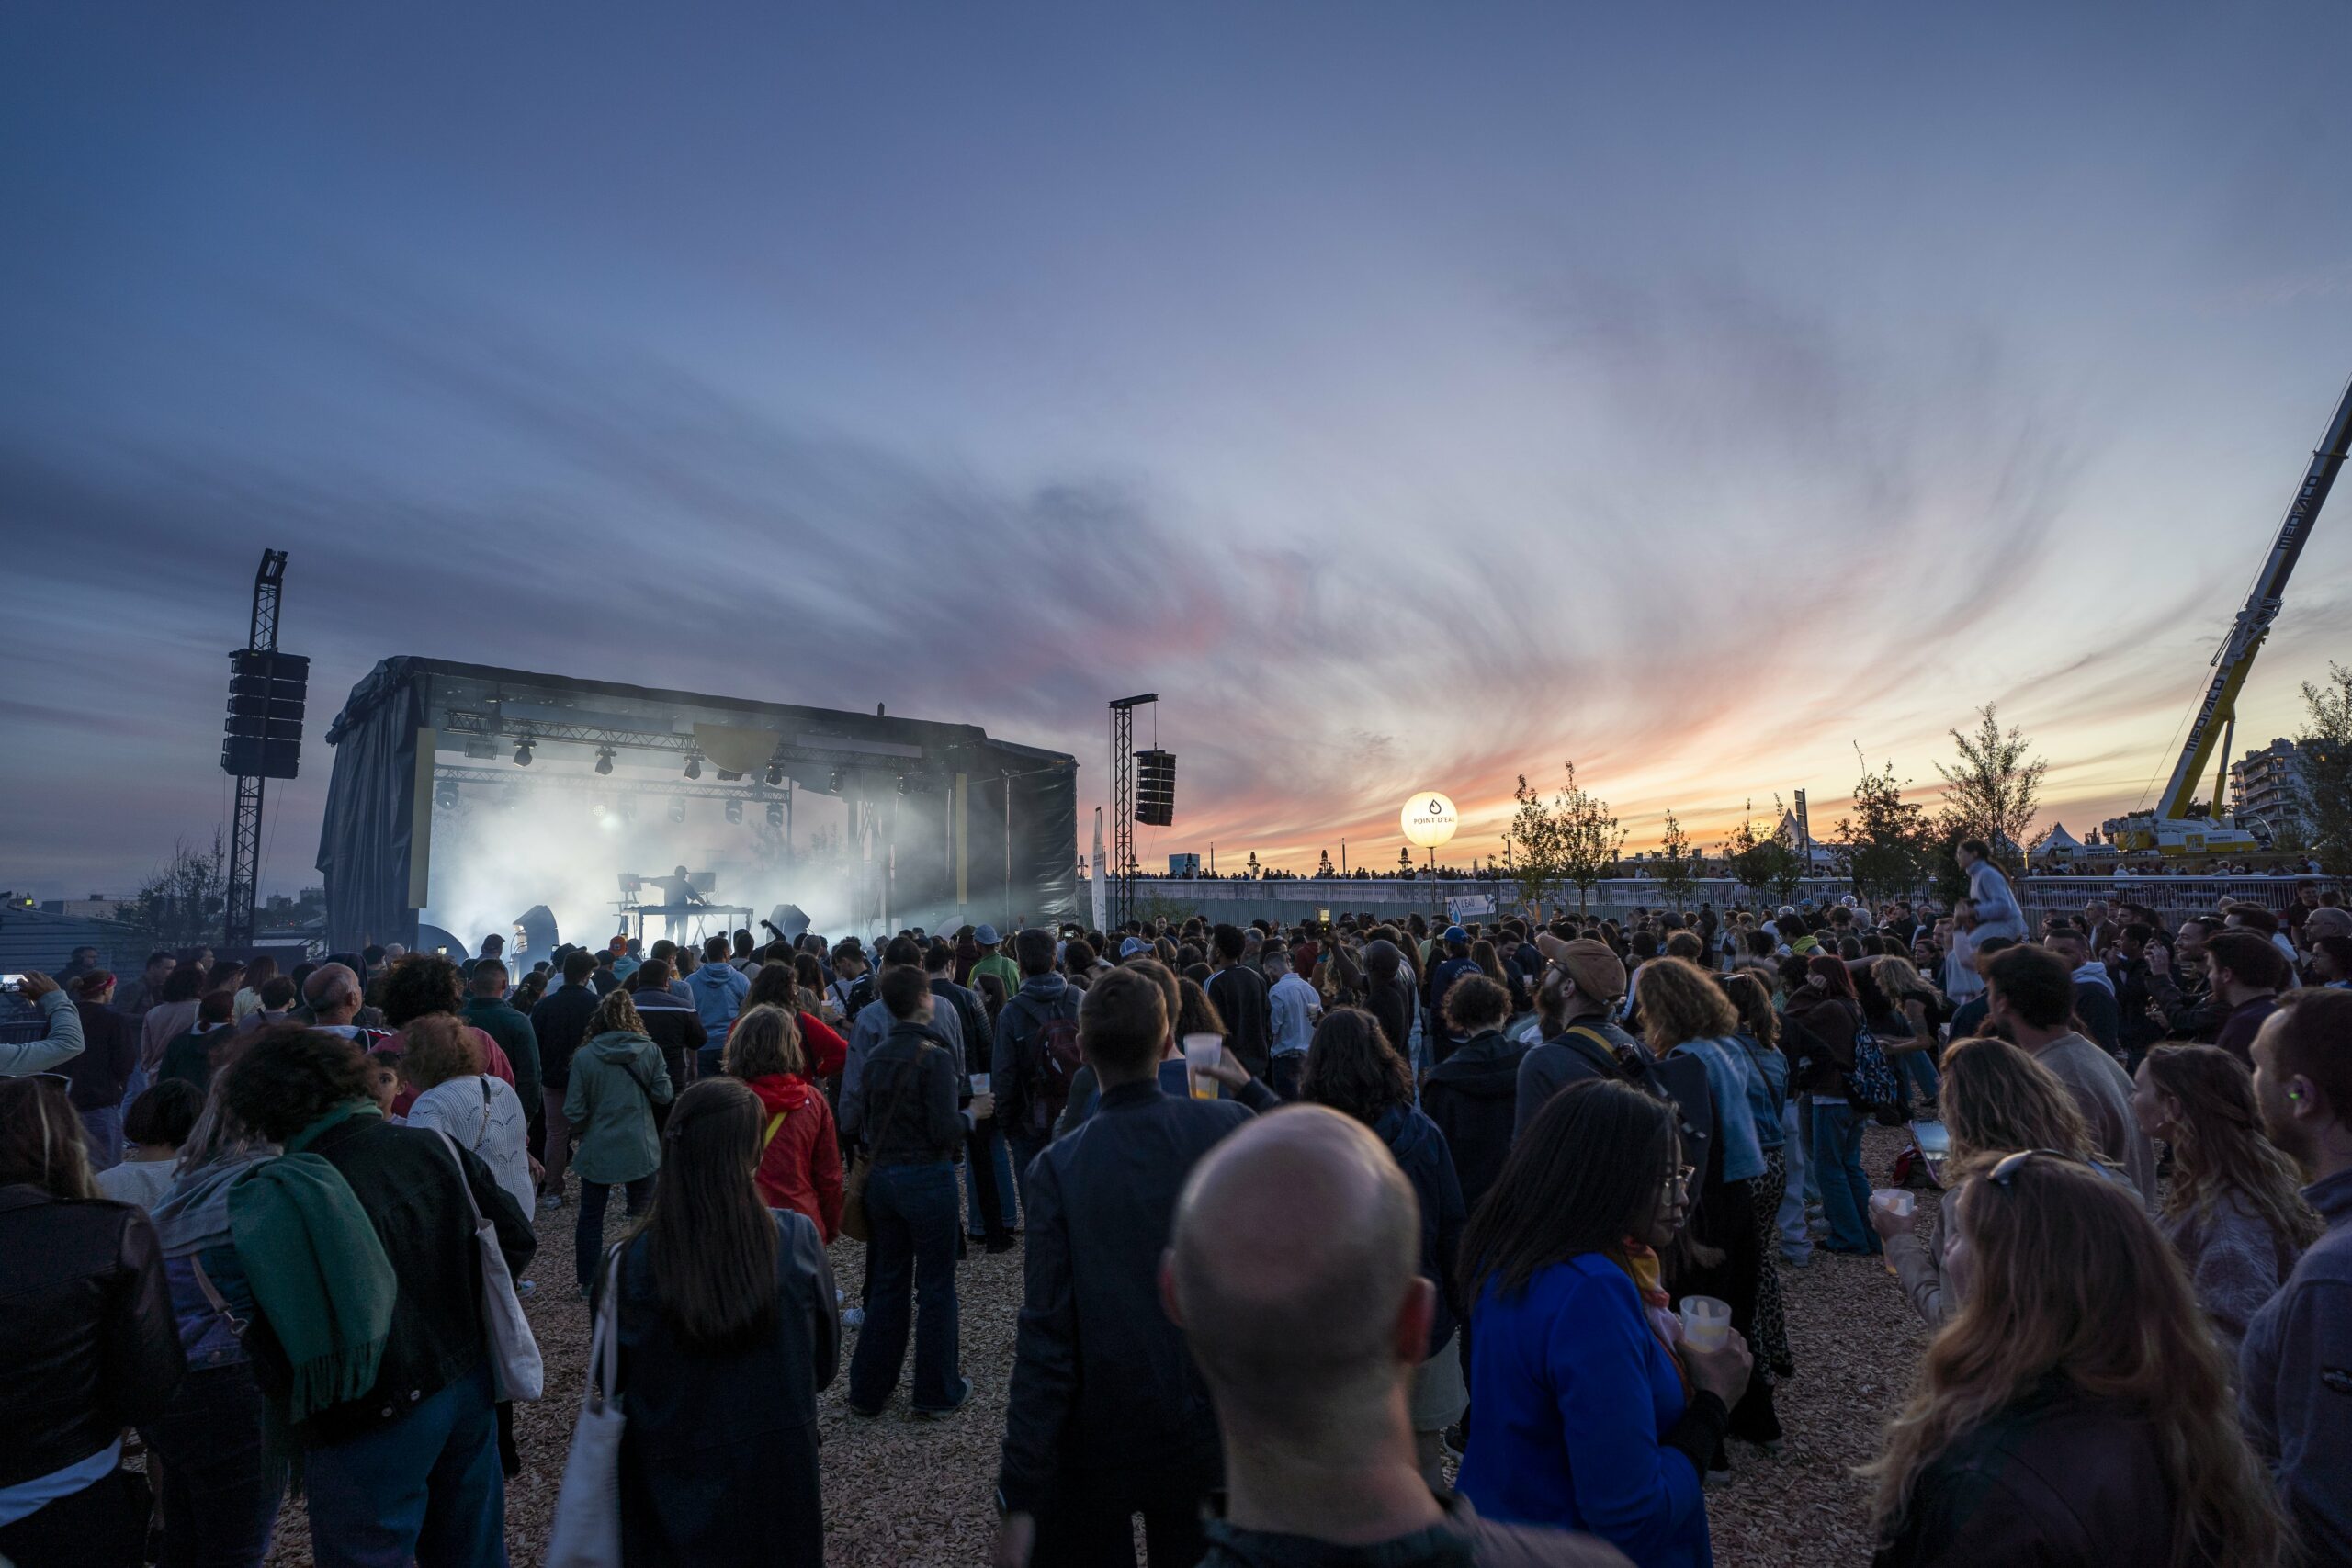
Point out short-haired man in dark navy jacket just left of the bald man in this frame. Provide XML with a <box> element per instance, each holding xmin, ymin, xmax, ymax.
<box><xmin>997</xmin><ymin>968</ymin><xmax>1251</xmax><ymax>1568</ymax></box>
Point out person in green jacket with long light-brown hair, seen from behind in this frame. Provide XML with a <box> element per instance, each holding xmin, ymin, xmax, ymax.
<box><xmin>564</xmin><ymin>989</ymin><xmax>675</xmax><ymax>1300</ymax></box>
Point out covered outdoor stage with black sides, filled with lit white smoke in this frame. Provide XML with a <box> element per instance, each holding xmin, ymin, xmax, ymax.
<box><xmin>318</xmin><ymin>659</ymin><xmax>1080</xmax><ymax>957</ymax></box>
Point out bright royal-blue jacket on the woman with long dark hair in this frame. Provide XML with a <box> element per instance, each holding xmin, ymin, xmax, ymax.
<box><xmin>1458</xmin><ymin>1253</ymin><xmax>1714</xmax><ymax>1568</ymax></box>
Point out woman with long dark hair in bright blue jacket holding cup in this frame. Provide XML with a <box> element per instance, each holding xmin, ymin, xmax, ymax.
<box><xmin>1458</xmin><ymin>1079</ymin><xmax>1747</xmax><ymax>1568</ymax></box>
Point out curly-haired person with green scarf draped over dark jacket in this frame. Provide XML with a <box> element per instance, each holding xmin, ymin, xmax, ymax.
<box><xmin>219</xmin><ymin>1030</ymin><xmax>537</xmax><ymax>1568</ymax></box>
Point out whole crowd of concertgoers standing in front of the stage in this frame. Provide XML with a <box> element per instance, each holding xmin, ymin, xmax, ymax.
<box><xmin>0</xmin><ymin>860</ymin><xmax>2352</xmax><ymax>1568</ymax></box>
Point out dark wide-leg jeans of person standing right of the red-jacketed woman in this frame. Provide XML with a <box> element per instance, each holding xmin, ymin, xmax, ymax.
<box><xmin>849</xmin><ymin>1164</ymin><xmax>959</xmax><ymax>1411</ymax></box>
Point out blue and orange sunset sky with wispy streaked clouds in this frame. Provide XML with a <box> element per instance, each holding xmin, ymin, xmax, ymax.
<box><xmin>0</xmin><ymin>0</ymin><xmax>2352</xmax><ymax>896</ymax></box>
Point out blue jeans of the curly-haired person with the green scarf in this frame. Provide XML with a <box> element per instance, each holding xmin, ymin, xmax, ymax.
<box><xmin>303</xmin><ymin>1361</ymin><xmax>505</xmax><ymax>1568</ymax></box>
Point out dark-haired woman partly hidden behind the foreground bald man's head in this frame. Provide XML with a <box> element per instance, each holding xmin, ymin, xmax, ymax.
<box><xmin>1298</xmin><ymin>1006</ymin><xmax>1470</xmax><ymax>1488</ymax></box>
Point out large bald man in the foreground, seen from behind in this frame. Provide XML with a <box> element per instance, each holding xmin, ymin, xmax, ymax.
<box><xmin>1159</xmin><ymin>1105</ymin><xmax>1625</xmax><ymax>1568</ymax></box>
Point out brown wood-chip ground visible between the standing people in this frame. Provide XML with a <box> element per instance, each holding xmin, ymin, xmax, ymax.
<box><xmin>270</xmin><ymin>1128</ymin><xmax>1933</xmax><ymax>1568</ymax></box>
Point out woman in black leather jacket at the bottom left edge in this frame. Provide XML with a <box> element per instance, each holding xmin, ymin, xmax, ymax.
<box><xmin>0</xmin><ymin>1075</ymin><xmax>186</xmax><ymax>1568</ymax></box>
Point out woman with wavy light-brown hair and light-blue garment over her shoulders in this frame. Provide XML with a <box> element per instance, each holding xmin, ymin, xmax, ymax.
<box><xmin>1634</xmin><ymin>959</ymin><xmax>1781</xmax><ymax>1443</ymax></box>
